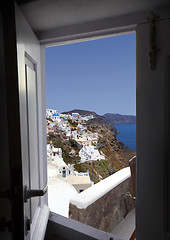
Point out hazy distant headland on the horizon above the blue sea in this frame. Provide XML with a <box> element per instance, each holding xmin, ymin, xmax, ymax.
<box><xmin>103</xmin><ymin>113</ymin><xmax>136</xmax><ymax>124</ymax></box>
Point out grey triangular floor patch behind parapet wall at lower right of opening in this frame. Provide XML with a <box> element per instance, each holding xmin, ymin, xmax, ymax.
<box><xmin>111</xmin><ymin>209</ymin><xmax>135</xmax><ymax>240</ymax></box>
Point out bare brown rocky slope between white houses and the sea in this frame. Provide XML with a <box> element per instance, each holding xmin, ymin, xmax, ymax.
<box><xmin>82</xmin><ymin>120</ymin><xmax>136</xmax><ymax>182</ymax></box>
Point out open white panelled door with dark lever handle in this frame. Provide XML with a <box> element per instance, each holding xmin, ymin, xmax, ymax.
<box><xmin>16</xmin><ymin>3</ymin><xmax>49</xmax><ymax>240</ymax></box>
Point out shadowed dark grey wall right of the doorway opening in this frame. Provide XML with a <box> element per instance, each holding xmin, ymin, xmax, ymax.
<box><xmin>136</xmin><ymin>20</ymin><xmax>170</xmax><ymax>240</ymax></box>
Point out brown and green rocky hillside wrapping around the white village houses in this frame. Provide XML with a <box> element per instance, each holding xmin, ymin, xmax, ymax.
<box><xmin>47</xmin><ymin>109</ymin><xmax>136</xmax><ymax>183</ymax></box>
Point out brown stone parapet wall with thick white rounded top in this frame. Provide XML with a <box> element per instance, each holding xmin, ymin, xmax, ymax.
<box><xmin>69</xmin><ymin>168</ymin><xmax>134</xmax><ymax>232</ymax></box>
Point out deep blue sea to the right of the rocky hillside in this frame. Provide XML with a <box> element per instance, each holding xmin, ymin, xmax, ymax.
<box><xmin>114</xmin><ymin>124</ymin><xmax>136</xmax><ymax>151</ymax></box>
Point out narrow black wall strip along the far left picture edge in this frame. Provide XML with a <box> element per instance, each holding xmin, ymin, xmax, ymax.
<box><xmin>0</xmin><ymin>12</ymin><xmax>11</xmax><ymax>240</ymax></box>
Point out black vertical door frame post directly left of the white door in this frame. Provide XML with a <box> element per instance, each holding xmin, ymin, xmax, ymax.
<box><xmin>2</xmin><ymin>1</ymin><xmax>25</xmax><ymax>240</ymax></box>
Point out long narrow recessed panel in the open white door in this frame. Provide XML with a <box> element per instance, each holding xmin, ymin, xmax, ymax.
<box><xmin>25</xmin><ymin>59</ymin><xmax>40</xmax><ymax>222</ymax></box>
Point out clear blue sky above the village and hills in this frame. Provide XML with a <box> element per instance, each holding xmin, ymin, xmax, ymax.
<box><xmin>46</xmin><ymin>33</ymin><xmax>136</xmax><ymax>115</ymax></box>
